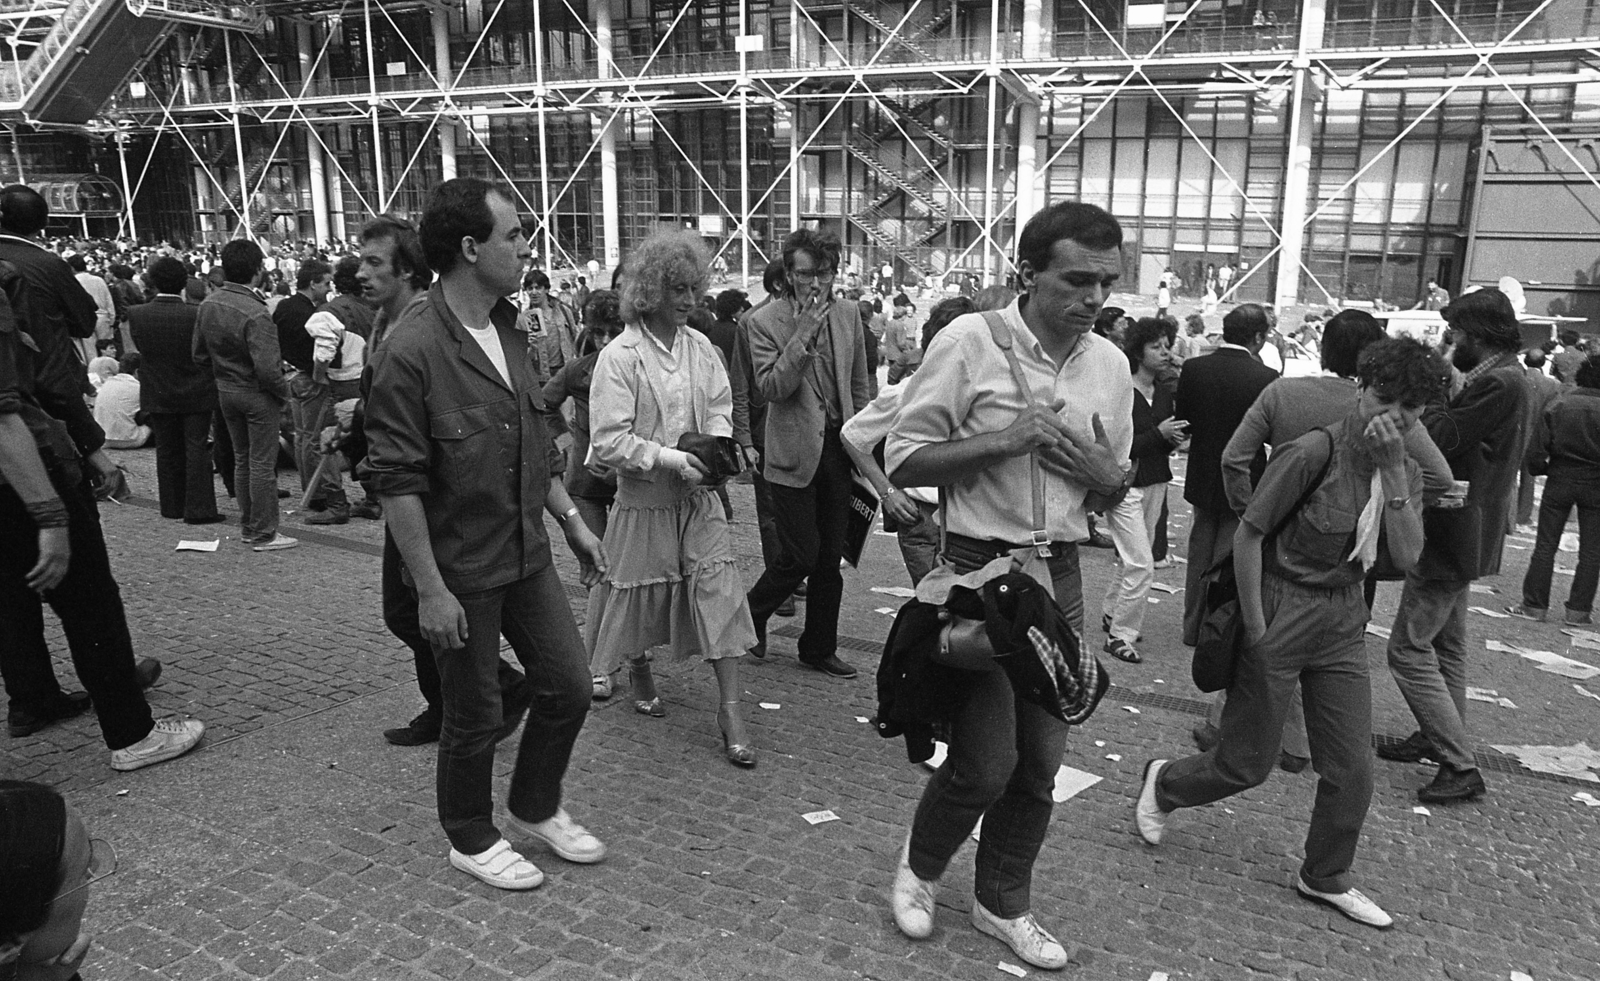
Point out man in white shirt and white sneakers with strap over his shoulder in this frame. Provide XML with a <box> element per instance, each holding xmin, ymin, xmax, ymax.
<box><xmin>885</xmin><ymin>202</ymin><xmax>1133</xmax><ymax>970</ymax></box>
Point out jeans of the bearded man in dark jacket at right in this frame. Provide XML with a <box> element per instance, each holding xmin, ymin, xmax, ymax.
<box><xmin>1389</xmin><ymin>575</ymin><xmax>1477</xmax><ymax>770</ymax></box>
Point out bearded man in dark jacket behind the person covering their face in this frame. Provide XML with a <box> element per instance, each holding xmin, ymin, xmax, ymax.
<box><xmin>1378</xmin><ymin>290</ymin><xmax>1531</xmax><ymax>803</ymax></box>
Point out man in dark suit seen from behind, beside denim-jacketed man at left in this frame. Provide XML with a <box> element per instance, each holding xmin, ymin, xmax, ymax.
<box><xmin>128</xmin><ymin>256</ymin><xmax>222</xmax><ymax>525</ymax></box>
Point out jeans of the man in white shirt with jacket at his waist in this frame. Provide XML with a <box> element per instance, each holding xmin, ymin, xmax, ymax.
<box><xmin>910</xmin><ymin>535</ymin><xmax>1083</xmax><ymax>919</ymax></box>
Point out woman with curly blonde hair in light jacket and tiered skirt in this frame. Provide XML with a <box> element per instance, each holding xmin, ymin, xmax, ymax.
<box><xmin>586</xmin><ymin>232</ymin><xmax>755</xmax><ymax>767</ymax></box>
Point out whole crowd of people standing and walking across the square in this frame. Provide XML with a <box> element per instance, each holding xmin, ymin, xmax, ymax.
<box><xmin>0</xmin><ymin>179</ymin><xmax>1600</xmax><ymax>968</ymax></box>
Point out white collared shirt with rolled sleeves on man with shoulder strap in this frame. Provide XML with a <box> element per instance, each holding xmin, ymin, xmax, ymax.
<box><xmin>885</xmin><ymin>299</ymin><xmax>1133</xmax><ymax>544</ymax></box>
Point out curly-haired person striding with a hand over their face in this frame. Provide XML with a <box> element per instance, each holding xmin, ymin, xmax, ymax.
<box><xmin>1134</xmin><ymin>338</ymin><xmax>1443</xmax><ymax>930</ymax></box>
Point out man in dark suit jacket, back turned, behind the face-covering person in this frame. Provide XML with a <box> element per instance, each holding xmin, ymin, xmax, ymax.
<box><xmin>1173</xmin><ymin>302</ymin><xmax>1278</xmax><ymax>647</ymax></box>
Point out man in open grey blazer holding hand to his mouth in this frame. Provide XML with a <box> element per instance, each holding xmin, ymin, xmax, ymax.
<box><xmin>749</xmin><ymin>229</ymin><xmax>869</xmax><ymax>679</ymax></box>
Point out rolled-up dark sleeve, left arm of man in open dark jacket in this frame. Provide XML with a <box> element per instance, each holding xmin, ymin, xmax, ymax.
<box><xmin>365</xmin><ymin>347</ymin><xmax>432</xmax><ymax>496</ymax></box>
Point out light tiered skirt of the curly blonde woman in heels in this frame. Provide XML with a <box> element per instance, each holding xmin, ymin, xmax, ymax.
<box><xmin>584</xmin><ymin>474</ymin><xmax>755</xmax><ymax>675</ymax></box>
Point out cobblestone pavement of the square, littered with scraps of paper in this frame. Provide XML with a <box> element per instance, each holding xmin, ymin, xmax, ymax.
<box><xmin>0</xmin><ymin>451</ymin><xmax>1600</xmax><ymax>981</ymax></box>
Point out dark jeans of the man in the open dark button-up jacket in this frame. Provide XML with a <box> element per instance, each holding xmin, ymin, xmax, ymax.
<box><xmin>434</xmin><ymin>565</ymin><xmax>590</xmax><ymax>855</ymax></box>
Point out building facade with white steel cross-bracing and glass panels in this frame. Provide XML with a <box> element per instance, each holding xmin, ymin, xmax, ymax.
<box><xmin>0</xmin><ymin>0</ymin><xmax>1600</xmax><ymax>326</ymax></box>
